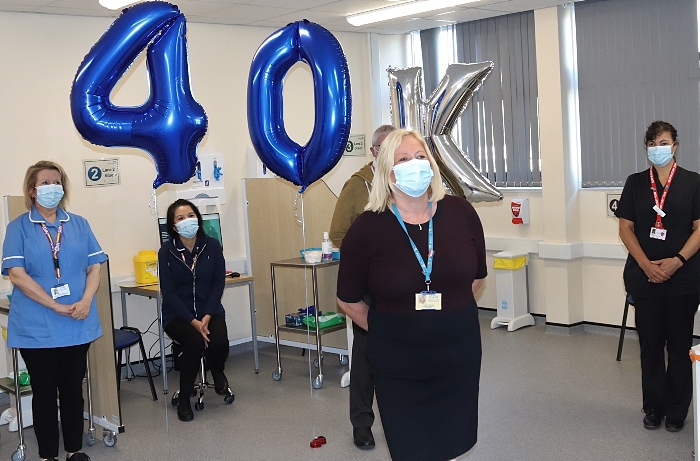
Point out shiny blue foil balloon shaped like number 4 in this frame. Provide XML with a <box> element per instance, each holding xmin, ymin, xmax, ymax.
<box><xmin>70</xmin><ymin>2</ymin><xmax>207</xmax><ymax>189</ymax></box>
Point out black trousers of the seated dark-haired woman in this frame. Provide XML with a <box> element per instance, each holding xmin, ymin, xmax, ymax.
<box><xmin>165</xmin><ymin>315</ymin><xmax>228</xmax><ymax>402</ymax></box>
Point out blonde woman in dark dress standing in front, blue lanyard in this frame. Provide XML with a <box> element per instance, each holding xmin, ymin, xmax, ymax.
<box><xmin>337</xmin><ymin>130</ymin><xmax>487</xmax><ymax>461</ymax></box>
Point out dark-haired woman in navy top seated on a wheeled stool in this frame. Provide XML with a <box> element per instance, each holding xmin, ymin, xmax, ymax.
<box><xmin>158</xmin><ymin>199</ymin><xmax>233</xmax><ymax>421</ymax></box>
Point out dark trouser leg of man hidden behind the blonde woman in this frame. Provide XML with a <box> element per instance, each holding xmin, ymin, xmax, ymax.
<box><xmin>350</xmin><ymin>323</ymin><xmax>374</xmax><ymax>427</ymax></box>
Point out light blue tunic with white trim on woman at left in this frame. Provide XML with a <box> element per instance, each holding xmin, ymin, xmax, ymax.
<box><xmin>2</xmin><ymin>207</ymin><xmax>107</xmax><ymax>349</ymax></box>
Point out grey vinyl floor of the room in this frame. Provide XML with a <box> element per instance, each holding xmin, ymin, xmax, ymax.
<box><xmin>0</xmin><ymin>317</ymin><xmax>693</xmax><ymax>461</ymax></box>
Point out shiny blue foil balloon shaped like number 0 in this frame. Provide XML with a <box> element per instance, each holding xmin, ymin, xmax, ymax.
<box><xmin>248</xmin><ymin>20</ymin><xmax>352</xmax><ymax>192</ymax></box>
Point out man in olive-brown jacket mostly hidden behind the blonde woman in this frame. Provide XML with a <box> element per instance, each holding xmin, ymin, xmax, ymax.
<box><xmin>329</xmin><ymin>125</ymin><xmax>396</xmax><ymax>450</ymax></box>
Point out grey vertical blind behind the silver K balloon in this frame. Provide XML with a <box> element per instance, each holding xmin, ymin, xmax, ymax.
<box><xmin>455</xmin><ymin>11</ymin><xmax>542</xmax><ymax>187</ymax></box>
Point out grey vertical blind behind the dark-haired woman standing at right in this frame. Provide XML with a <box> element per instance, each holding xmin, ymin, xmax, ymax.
<box><xmin>575</xmin><ymin>0</ymin><xmax>700</xmax><ymax>187</ymax></box>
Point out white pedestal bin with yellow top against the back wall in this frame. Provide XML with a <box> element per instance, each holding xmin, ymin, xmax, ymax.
<box><xmin>491</xmin><ymin>251</ymin><xmax>535</xmax><ymax>331</ymax></box>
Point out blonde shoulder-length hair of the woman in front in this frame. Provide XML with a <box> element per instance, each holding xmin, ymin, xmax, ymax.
<box><xmin>365</xmin><ymin>129</ymin><xmax>445</xmax><ymax>212</ymax></box>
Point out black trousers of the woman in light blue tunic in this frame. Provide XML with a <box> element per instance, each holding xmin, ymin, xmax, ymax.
<box><xmin>20</xmin><ymin>343</ymin><xmax>90</xmax><ymax>459</ymax></box>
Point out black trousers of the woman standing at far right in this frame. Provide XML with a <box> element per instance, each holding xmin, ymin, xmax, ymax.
<box><xmin>634</xmin><ymin>293</ymin><xmax>699</xmax><ymax>421</ymax></box>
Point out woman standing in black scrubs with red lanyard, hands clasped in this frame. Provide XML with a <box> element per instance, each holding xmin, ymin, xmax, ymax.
<box><xmin>615</xmin><ymin>121</ymin><xmax>700</xmax><ymax>432</ymax></box>
